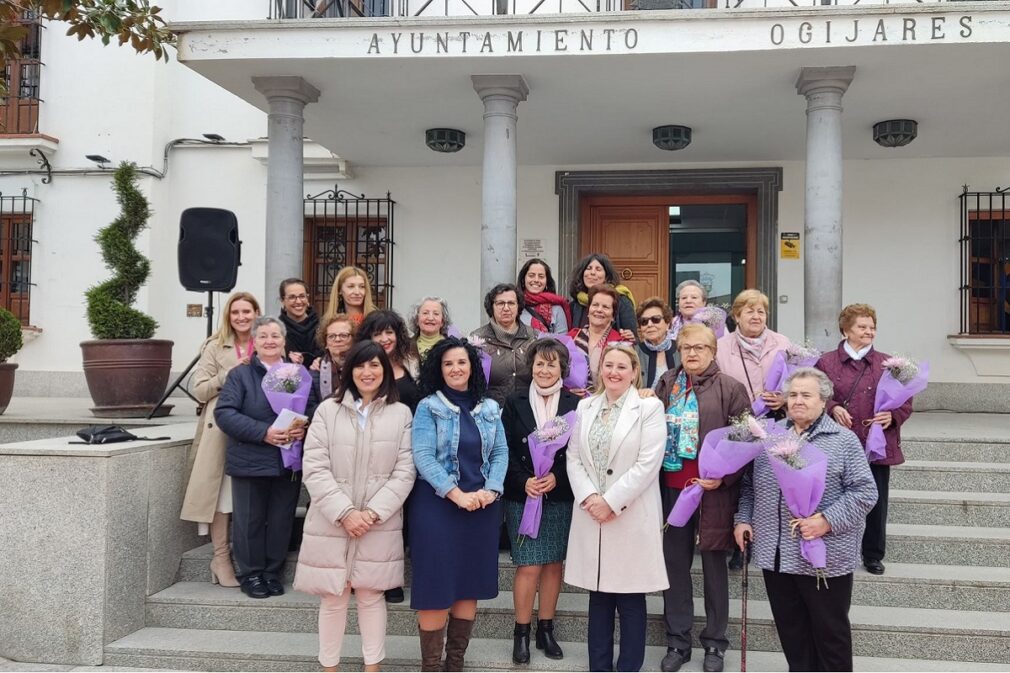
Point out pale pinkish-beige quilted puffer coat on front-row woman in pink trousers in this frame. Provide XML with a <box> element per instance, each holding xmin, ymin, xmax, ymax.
<box><xmin>295</xmin><ymin>392</ymin><xmax>416</xmax><ymax>595</ymax></box>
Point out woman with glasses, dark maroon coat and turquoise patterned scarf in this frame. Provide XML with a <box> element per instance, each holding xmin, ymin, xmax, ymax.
<box><xmin>655</xmin><ymin>323</ymin><xmax>750</xmax><ymax>671</ymax></box>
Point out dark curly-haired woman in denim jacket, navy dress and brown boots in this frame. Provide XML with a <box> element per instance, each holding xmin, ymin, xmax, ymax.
<box><xmin>407</xmin><ymin>337</ymin><xmax>508</xmax><ymax>671</ymax></box>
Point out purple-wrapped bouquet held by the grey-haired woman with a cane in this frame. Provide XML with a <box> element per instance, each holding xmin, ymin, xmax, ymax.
<box><xmin>768</xmin><ymin>432</ymin><xmax>827</xmax><ymax>570</ymax></box>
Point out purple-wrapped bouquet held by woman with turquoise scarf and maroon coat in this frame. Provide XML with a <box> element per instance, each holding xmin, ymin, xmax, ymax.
<box><xmin>667</xmin><ymin>413</ymin><xmax>783</xmax><ymax>527</ymax></box>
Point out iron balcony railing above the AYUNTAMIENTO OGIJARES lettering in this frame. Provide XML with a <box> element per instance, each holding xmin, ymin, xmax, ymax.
<box><xmin>269</xmin><ymin>0</ymin><xmax>945</xmax><ymax>19</ymax></box>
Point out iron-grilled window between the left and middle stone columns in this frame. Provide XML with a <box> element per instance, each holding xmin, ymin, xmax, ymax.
<box><xmin>304</xmin><ymin>187</ymin><xmax>396</xmax><ymax>315</ymax></box>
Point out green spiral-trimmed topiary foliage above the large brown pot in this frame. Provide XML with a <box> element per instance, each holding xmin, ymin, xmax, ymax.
<box><xmin>85</xmin><ymin>162</ymin><xmax>158</xmax><ymax>339</ymax></box>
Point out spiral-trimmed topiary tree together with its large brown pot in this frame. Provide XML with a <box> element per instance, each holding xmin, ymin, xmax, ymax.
<box><xmin>81</xmin><ymin>163</ymin><xmax>173</xmax><ymax>418</ymax></box>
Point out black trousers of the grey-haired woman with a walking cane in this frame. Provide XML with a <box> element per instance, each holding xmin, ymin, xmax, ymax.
<box><xmin>765</xmin><ymin>570</ymin><xmax>852</xmax><ymax>671</ymax></box>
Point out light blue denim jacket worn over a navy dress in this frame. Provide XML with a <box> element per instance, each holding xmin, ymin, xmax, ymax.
<box><xmin>411</xmin><ymin>392</ymin><xmax>508</xmax><ymax>497</ymax></box>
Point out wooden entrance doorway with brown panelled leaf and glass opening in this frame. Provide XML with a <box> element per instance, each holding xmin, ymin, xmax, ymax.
<box><xmin>580</xmin><ymin>194</ymin><xmax>758</xmax><ymax>305</ymax></box>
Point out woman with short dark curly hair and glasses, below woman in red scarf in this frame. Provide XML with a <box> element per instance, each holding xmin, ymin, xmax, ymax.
<box><xmin>470</xmin><ymin>283</ymin><xmax>536</xmax><ymax>406</ymax></box>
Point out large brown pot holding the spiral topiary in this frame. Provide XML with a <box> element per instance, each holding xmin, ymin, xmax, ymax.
<box><xmin>81</xmin><ymin>339</ymin><xmax>173</xmax><ymax>418</ymax></box>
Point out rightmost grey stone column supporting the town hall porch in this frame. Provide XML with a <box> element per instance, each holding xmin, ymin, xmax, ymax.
<box><xmin>796</xmin><ymin>66</ymin><xmax>855</xmax><ymax>350</ymax></box>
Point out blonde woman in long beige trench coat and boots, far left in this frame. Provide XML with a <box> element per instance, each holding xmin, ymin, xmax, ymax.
<box><xmin>180</xmin><ymin>292</ymin><xmax>260</xmax><ymax>587</ymax></box>
